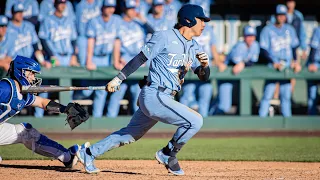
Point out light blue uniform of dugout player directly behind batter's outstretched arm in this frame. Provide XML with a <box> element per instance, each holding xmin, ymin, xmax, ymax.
<box><xmin>114</xmin><ymin>20</ymin><xmax>149</xmax><ymax>112</ymax></box>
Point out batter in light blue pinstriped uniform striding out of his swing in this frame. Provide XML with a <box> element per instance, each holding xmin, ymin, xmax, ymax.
<box><xmin>77</xmin><ymin>4</ymin><xmax>210</xmax><ymax>175</ymax></box>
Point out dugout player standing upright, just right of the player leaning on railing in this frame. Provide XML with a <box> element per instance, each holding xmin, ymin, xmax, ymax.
<box><xmin>259</xmin><ymin>4</ymin><xmax>301</xmax><ymax>117</ymax></box>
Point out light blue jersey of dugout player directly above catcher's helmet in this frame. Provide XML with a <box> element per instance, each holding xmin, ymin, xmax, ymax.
<box><xmin>8</xmin><ymin>21</ymin><xmax>39</xmax><ymax>58</ymax></box>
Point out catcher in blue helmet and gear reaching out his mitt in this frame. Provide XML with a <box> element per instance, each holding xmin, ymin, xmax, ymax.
<box><xmin>0</xmin><ymin>56</ymin><xmax>89</xmax><ymax>168</ymax></box>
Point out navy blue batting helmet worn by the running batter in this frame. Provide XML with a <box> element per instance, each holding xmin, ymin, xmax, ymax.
<box><xmin>178</xmin><ymin>4</ymin><xmax>210</xmax><ymax>27</ymax></box>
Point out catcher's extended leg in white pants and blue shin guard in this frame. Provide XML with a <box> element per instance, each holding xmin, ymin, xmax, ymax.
<box><xmin>0</xmin><ymin>123</ymin><xmax>71</xmax><ymax>162</ymax></box>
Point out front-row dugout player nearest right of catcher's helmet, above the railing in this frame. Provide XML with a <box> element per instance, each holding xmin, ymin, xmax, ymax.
<box><xmin>39</xmin><ymin>0</ymin><xmax>79</xmax><ymax>66</ymax></box>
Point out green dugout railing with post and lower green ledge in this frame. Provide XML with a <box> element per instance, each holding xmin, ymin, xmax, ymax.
<box><xmin>4</xmin><ymin>65</ymin><xmax>320</xmax><ymax>132</ymax></box>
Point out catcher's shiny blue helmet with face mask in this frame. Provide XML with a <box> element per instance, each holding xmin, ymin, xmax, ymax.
<box><xmin>8</xmin><ymin>56</ymin><xmax>41</xmax><ymax>86</ymax></box>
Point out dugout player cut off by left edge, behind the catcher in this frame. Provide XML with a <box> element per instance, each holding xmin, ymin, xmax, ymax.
<box><xmin>0</xmin><ymin>15</ymin><xmax>17</xmax><ymax>71</ymax></box>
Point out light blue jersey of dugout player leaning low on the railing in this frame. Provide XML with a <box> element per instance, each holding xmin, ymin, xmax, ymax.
<box><xmin>225</xmin><ymin>41</ymin><xmax>260</xmax><ymax>64</ymax></box>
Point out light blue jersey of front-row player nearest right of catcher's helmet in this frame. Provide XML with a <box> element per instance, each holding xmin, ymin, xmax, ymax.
<box><xmin>39</xmin><ymin>15</ymin><xmax>77</xmax><ymax>55</ymax></box>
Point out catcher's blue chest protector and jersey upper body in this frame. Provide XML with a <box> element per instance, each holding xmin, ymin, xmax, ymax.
<box><xmin>0</xmin><ymin>78</ymin><xmax>35</xmax><ymax>124</ymax></box>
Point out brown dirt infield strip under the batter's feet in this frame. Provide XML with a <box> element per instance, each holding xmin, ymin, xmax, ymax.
<box><xmin>0</xmin><ymin>160</ymin><xmax>320</xmax><ymax>180</ymax></box>
